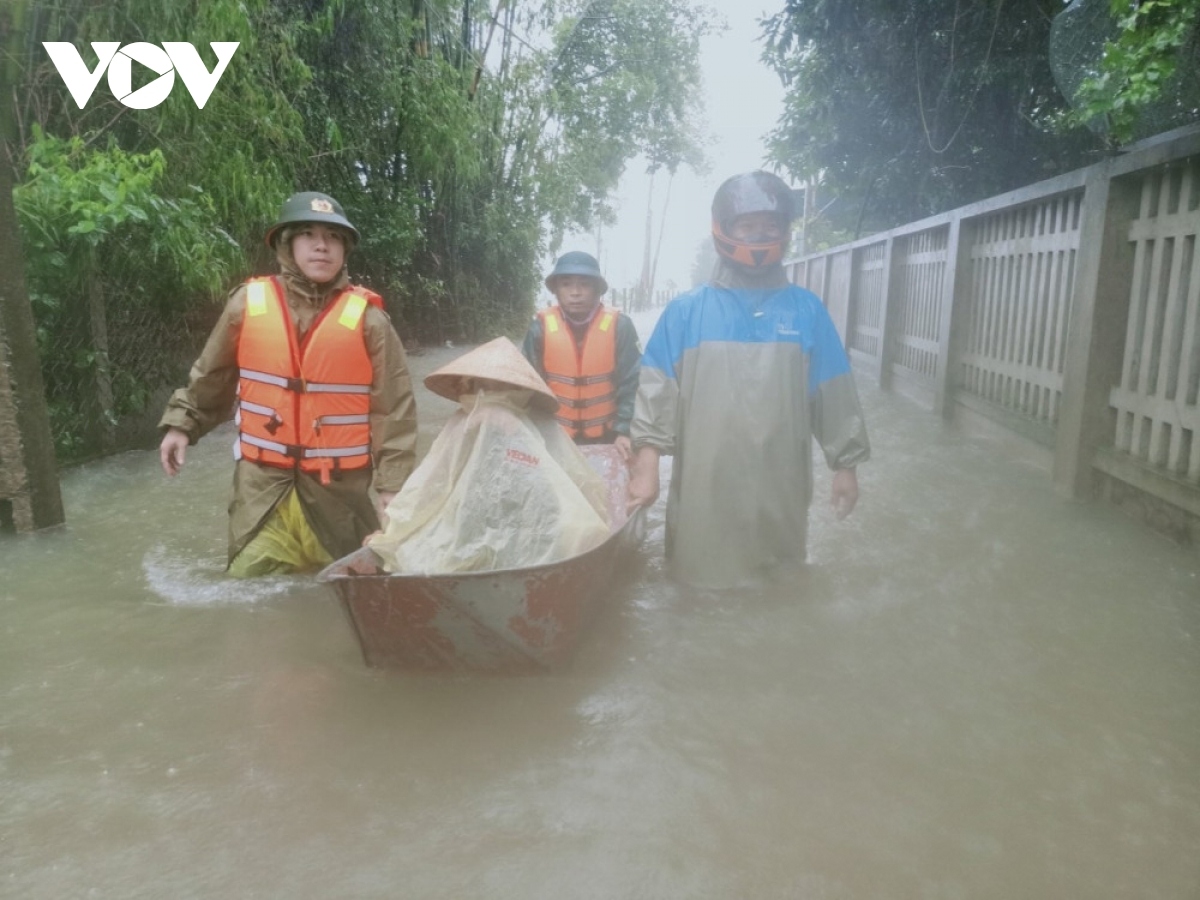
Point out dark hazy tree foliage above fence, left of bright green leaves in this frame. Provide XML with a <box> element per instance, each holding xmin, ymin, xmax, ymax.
<box><xmin>764</xmin><ymin>0</ymin><xmax>1102</xmax><ymax>234</ymax></box>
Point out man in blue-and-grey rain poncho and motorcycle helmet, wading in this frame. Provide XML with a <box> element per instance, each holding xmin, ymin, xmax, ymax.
<box><xmin>629</xmin><ymin>172</ymin><xmax>870</xmax><ymax>588</ymax></box>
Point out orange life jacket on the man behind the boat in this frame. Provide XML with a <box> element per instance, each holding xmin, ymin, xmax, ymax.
<box><xmin>538</xmin><ymin>306</ymin><xmax>617</xmax><ymax>440</ymax></box>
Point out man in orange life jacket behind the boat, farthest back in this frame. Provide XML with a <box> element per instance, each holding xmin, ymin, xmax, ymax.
<box><xmin>521</xmin><ymin>250</ymin><xmax>642</xmax><ymax>461</ymax></box>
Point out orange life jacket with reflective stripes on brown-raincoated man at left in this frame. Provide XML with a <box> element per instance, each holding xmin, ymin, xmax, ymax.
<box><xmin>234</xmin><ymin>278</ymin><xmax>383</xmax><ymax>485</ymax></box>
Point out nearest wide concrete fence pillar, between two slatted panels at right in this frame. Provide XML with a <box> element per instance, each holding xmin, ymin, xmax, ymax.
<box><xmin>1052</xmin><ymin>163</ymin><xmax>1140</xmax><ymax>499</ymax></box>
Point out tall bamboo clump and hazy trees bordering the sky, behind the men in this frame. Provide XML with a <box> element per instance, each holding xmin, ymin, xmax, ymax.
<box><xmin>288</xmin><ymin>0</ymin><xmax>707</xmax><ymax>341</ymax></box>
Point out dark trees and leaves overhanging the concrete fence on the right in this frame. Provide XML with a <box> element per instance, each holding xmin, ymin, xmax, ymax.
<box><xmin>764</xmin><ymin>0</ymin><xmax>1200</xmax><ymax>240</ymax></box>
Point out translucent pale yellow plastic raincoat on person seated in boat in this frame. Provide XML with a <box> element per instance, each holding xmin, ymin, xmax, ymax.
<box><xmin>367</xmin><ymin>390</ymin><xmax>608</xmax><ymax>575</ymax></box>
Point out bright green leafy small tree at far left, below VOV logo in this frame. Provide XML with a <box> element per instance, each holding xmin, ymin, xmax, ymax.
<box><xmin>13</xmin><ymin>126</ymin><xmax>241</xmax><ymax>460</ymax></box>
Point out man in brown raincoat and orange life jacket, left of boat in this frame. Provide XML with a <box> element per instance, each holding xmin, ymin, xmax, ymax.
<box><xmin>160</xmin><ymin>191</ymin><xmax>416</xmax><ymax>576</ymax></box>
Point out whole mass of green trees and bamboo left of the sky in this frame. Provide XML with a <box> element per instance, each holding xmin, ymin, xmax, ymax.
<box><xmin>0</xmin><ymin>0</ymin><xmax>709</xmax><ymax>458</ymax></box>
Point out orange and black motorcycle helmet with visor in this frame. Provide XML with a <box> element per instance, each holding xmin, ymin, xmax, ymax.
<box><xmin>713</xmin><ymin>172</ymin><xmax>796</xmax><ymax>269</ymax></box>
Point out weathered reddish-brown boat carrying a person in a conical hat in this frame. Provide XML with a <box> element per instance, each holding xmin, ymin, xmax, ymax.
<box><xmin>317</xmin><ymin>445</ymin><xmax>643</xmax><ymax>673</ymax></box>
